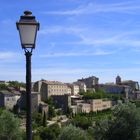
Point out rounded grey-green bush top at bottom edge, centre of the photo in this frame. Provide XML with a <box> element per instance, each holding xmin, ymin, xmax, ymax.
<box><xmin>58</xmin><ymin>125</ymin><xmax>91</xmax><ymax>140</ymax></box>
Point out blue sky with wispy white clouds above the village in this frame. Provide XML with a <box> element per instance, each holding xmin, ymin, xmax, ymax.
<box><xmin>0</xmin><ymin>0</ymin><xmax>140</xmax><ymax>83</ymax></box>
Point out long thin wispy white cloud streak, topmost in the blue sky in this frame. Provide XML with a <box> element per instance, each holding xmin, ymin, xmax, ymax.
<box><xmin>41</xmin><ymin>1</ymin><xmax>140</xmax><ymax>16</ymax></box>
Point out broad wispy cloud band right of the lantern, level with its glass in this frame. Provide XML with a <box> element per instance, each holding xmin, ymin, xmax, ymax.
<box><xmin>40</xmin><ymin>25</ymin><xmax>140</xmax><ymax>47</ymax></box>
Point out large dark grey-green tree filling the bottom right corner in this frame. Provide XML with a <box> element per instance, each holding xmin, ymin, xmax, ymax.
<box><xmin>94</xmin><ymin>103</ymin><xmax>140</xmax><ymax>140</ymax></box>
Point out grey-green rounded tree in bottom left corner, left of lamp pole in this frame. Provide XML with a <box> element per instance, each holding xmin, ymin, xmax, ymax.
<box><xmin>0</xmin><ymin>110</ymin><xmax>22</xmax><ymax>140</ymax></box>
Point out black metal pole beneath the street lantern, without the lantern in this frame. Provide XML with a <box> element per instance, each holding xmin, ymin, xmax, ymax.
<box><xmin>25</xmin><ymin>51</ymin><xmax>32</xmax><ymax>140</ymax></box>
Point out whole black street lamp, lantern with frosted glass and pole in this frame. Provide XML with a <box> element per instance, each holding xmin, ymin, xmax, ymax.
<box><xmin>16</xmin><ymin>11</ymin><xmax>39</xmax><ymax>140</ymax></box>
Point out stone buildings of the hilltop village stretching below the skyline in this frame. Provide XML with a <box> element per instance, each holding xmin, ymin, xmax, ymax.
<box><xmin>0</xmin><ymin>76</ymin><xmax>140</xmax><ymax>115</ymax></box>
